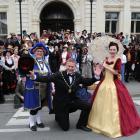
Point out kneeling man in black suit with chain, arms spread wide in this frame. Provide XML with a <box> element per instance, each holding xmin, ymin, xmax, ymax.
<box><xmin>30</xmin><ymin>58</ymin><xmax>101</xmax><ymax>131</ymax></box>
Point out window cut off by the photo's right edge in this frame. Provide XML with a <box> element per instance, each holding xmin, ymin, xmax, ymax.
<box><xmin>131</xmin><ymin>13</ymin><xmax>140</xmax><ymax>34</ymax></box>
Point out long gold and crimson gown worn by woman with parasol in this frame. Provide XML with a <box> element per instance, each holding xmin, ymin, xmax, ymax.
<box><xmin>88</xmin><ymin>58</ymin><xmax>140</xmax><ymax>138</ymax></box>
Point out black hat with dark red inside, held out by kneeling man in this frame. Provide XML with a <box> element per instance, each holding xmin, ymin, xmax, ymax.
<box><xmin>18</xmin><ymin>55</ymin><xmax>34</xmax><ymax>75</ymax></box>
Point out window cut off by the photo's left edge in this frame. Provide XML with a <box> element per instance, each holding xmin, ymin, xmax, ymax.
<box><xmin>0</xmin><ymin>12</ymin><xmax>7</xmax><ymax>39</ymax></box>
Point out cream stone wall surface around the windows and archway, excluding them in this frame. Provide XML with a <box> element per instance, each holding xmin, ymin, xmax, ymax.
<box><xmin>0</xmin><ymin>0</ymin><xmax>140</xmax><ymax>34</ymax></box>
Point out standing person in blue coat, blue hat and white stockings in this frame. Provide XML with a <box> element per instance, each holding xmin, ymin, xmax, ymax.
<box><xmin>24</xmin><ymin>43</ymin><xmax>52</xmax><ymax>131</ymax></box>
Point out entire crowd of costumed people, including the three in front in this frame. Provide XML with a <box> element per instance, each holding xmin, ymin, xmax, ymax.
<box><xmin>0</xmin><ymin>30</ymin><xmax>140</xmax><ymax>138</ymax></box>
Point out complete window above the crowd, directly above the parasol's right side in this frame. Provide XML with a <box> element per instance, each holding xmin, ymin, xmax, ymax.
<box><xmin>105</xmin><ymin>12</ymin><xmax>119</xmax><ymax>34</ymax></box>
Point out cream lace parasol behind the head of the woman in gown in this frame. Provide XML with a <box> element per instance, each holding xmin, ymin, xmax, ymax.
<box><xmin>89</xmin><ymin>35</ymin><xmax>124</xmax><ymax>63</ymax></box>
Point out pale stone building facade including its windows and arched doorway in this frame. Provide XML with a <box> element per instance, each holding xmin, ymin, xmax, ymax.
<box><xmin>0</xmin><ymin>0</ymin><xmax>140</xmax><ymax>36</ymax></box>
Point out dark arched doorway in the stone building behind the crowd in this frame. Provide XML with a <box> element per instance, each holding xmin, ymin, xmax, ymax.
<box><xmin>40</xmin><ymin>1</ymin><xmax>74</xmax><ymax>33</ymax></box>
